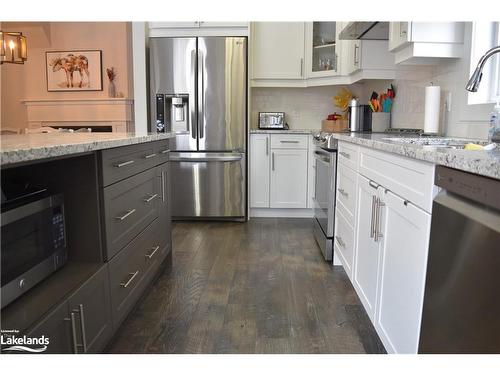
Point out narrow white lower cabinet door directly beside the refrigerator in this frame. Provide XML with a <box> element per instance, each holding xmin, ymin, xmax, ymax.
<box><xmin>250</xmin><ymin>134</ymin><xmax>270</xmax><ymax>208</ymax></box>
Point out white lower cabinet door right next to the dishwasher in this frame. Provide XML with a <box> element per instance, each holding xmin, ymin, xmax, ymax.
<box><xmin>375</xmin><ymin>191</ymin><xmax>431</xmax><ymax>353</ymax></box>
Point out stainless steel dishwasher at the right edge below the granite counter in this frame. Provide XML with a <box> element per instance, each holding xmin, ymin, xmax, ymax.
<box><xmin>419</xmin><ymin>166</ymin><xmax>500</xmax><ymax>353</ymax></box>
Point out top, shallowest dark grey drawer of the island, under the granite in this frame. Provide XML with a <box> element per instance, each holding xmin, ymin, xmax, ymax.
<box><xmin>99</xmin><ymin>142</ymin><xmax>165</xmax><ymax>186</ymax></box>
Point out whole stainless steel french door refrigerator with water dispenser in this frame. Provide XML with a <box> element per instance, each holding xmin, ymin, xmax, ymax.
<box><xmin>149</xmin><ymin>37</ymin><xmax>247</xmax><ymax>220</ymax></box>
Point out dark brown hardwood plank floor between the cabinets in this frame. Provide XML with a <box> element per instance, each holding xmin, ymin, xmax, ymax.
<box><xmin>108</xmin><ymin>219</ymin><xmax>384</xmax><ymax>353</ymax></box>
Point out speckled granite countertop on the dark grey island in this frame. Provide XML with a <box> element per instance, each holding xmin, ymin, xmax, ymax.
<box><xmin>0</xmin><ymin>133</ymin><xmax>173</xmax><ymax>165</ymax></box>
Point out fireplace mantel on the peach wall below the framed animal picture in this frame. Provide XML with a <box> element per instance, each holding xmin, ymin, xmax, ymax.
<box><xmin>22</xmin><ymin>98</ymin><xmax>134</xmax><ymax>132</ymax></box>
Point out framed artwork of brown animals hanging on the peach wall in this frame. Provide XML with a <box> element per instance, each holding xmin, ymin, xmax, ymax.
<box><xmin>45</xmin><ymin>50</ymin><xmax>102</xmax><ymax>91</ymax></box>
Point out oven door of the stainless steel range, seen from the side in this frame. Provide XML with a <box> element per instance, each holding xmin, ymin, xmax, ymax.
<box><xmin>314</xmin><ymin>148</ymin><xmax>337</xmax><ymax>237</ymax></box>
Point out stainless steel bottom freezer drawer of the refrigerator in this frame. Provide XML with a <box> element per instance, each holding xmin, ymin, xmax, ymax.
<box><xmin>170</xmin><ymin>152</ymin><xmax>246</xmax><ymax>219</ymax></box>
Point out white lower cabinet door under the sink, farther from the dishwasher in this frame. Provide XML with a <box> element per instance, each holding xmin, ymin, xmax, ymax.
<box><xmin>353</xmin><ymin>175</ymin><xmax>380</xmax><ymax>322</ymax></box>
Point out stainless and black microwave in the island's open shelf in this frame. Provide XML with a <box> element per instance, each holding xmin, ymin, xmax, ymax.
<box><xmin>0</xmin><ymin>194</ymin><xmax>68</xmax><ymax>308</ymax></box>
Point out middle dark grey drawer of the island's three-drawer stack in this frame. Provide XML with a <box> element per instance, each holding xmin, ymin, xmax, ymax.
<box><xmin>103</xmin><ymin>168</ymin><xmax>162</xmax><ymax>260</ymax></box>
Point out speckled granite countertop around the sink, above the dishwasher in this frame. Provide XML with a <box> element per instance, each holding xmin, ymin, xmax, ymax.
<box><xmin>333</xmin><ymin>133</ymin><xmax>500</xmax><ymax>179</ymax></box>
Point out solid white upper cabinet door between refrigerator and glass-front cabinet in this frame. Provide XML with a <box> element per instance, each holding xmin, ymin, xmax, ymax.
<box><xmin>251</xmin><ymin>22</ymin><xmax>304</xmax><ymax>80</ymax></box>
